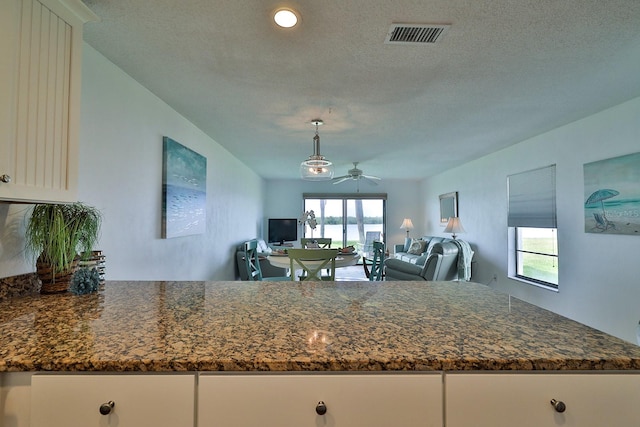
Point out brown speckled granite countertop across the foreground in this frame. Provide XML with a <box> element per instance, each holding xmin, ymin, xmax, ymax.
<box><xmin>0</xmin><ymin>282</ymin><xmax>640</xmax><ymax>372</ymax></box>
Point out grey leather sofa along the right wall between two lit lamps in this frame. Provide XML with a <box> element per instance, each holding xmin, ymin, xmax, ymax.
<box><xmin>384</xmin><ymin>236</ymin><xmax>473</xmax><ymax>281</ymax></box>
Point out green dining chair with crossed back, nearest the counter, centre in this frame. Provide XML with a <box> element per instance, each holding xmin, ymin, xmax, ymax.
<box><xmin>287</xmin><ymin>249</ymin><xmax>338</xmax><ymax>281</ymax></box>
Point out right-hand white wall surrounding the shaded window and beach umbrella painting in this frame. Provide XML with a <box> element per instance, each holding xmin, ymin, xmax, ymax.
<box><xmin>422</xmin><ymin>98</ymin><xmax>640</xmax><ymax>343</ymax></box>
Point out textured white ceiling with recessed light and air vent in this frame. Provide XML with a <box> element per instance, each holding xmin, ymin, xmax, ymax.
<box><xmin>84</xmin><ymin>0</ymin><xmax>640</xmax><ymax>179</ymax></box>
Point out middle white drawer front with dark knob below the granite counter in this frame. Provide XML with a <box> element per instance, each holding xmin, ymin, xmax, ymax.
<box><xmin>198</xmin><ymin>373</ymin><xmax>443</xmax><ymax>427</ymax></box>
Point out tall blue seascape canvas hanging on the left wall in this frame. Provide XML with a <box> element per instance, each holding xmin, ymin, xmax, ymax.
<box><xmin>162</xmin><ymin>136</ymin><xmax>207</xmax><ymax>239</ymax></box>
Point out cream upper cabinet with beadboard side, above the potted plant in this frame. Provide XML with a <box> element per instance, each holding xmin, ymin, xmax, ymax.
<box><xmin>0</xmin><ymin>0</ymin><xmax>97</xmax><ymax>202</ymax></box>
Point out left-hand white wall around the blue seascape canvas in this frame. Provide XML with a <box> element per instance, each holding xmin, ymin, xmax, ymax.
<box><xmin>0</xmin><ymin>44</ymin><xmax>264</xmax><ymax>280</ymax></box>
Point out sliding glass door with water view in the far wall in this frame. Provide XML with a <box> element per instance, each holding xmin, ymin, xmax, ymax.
<box><xmin>304</xmin><ymin>194</ymin><xmax>387</xmax><ymax>253</ymax></box>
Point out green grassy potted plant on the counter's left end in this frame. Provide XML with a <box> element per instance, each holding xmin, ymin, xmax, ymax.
<box><xmin>25</xmin><ymin>203</ymin><xmax>102</xmax><ymax>293</ymax></box>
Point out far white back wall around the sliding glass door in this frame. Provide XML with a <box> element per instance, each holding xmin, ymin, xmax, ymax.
<box><xmin>263</xmin><ymin>180</ymin><xmax>424</xmax><ymax>244</ymax></box>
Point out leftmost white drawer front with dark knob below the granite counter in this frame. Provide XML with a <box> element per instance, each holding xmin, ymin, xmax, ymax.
<box><xmin>31</xmin><ymin>374</ymin><xmax>195</xmax><ymax>427</ymax></box>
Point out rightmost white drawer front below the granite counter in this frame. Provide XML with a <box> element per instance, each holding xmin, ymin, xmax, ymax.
<box><xmin>445</xmin><ymin>372</ymin><xmax>640</xmax><ymax>427</ymax></box>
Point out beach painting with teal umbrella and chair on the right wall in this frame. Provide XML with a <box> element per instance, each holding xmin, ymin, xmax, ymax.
<box><xmin>584</xmin><ymin>153</ymin><xmax>640</xmax><ymax>235</ymax></box>
